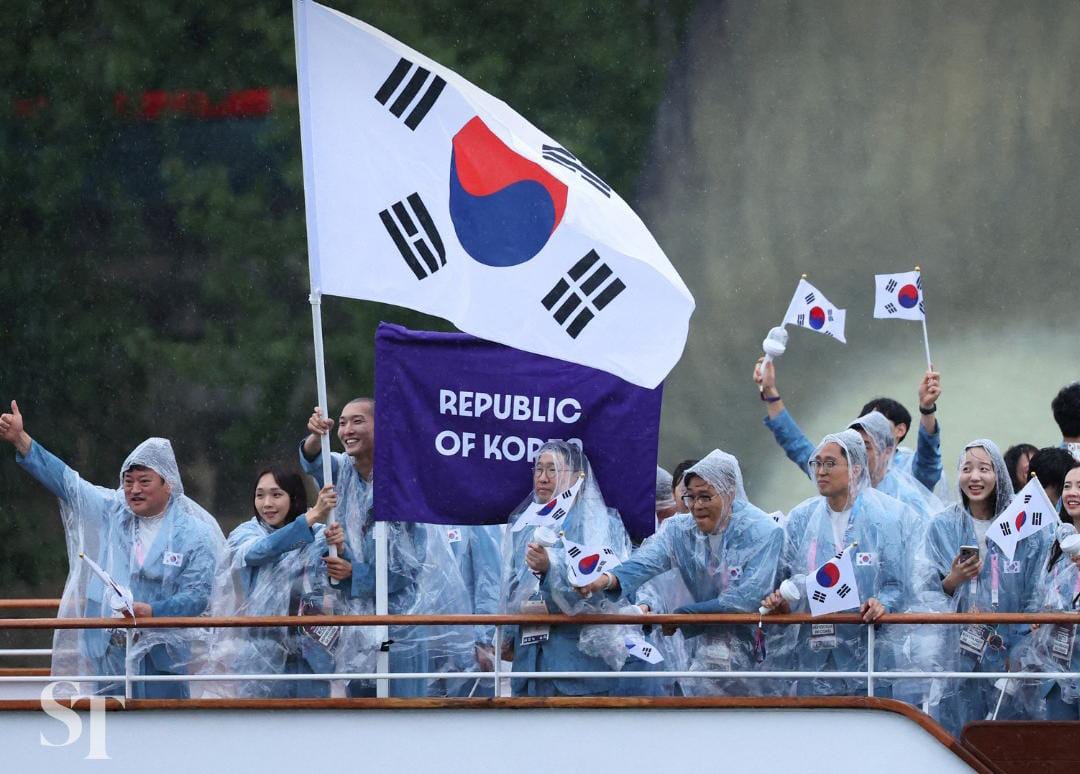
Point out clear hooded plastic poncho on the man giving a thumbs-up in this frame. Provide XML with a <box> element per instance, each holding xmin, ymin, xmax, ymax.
<box><xmin>44</xmin><ymin>438</ymin><xmax>225</xmax><ymax>697</ymax></box>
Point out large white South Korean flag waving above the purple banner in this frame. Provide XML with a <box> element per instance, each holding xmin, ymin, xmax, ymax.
<box><xmin>294</xmin><ymin>0</ymin><xmax>694</xmax><ymax>388</ymax></box>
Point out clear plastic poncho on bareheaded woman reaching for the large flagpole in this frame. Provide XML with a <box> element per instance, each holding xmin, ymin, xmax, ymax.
<box><xmin>211</xmin><ymin>513</ymin><xmax>332</xmax><ymax>698</ymax></box>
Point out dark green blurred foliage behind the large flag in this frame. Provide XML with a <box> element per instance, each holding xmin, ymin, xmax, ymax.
<box><xmin>0</xmin><ymin>0</ymin><xmax>692</xmax><ymax>596</ymax></box>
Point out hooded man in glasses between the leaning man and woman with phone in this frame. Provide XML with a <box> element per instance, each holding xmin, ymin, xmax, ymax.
<box><xmin>761</xmin><ymin>430</ymin><xmax>909</xmax><ymax>695</ymax></box>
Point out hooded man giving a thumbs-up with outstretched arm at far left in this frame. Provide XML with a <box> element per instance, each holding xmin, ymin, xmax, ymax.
<box><xmin>0</xmin><ymin>402</ymin><xmax>225</xmax><ymax>698</ymax></box>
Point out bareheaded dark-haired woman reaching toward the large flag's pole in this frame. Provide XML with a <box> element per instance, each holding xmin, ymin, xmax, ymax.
<box><xmin>214</xmin><ymin>467</ymin><xmax>340</xmax><ymax>698</ymax></box>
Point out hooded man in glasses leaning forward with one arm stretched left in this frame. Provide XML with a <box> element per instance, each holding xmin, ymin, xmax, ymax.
<box><xmin>581</xmin><ymin>449</ymin><xmax>784</xmax><ymax>695</ymax></box>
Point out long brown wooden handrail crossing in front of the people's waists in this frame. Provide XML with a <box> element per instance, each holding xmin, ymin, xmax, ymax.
<box><xmin>0</xmin><ymin>612</ymin><xmax>1080</xmax><ymax>630</ymax></box>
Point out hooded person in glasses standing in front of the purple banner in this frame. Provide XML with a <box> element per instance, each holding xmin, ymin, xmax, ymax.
<box><xmin>502</xmin><ymin>442</ymin><xmax>630</xmax><ymax>696</ymax></box>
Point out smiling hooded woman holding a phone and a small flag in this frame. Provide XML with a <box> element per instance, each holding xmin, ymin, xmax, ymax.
<box><xmin>922</xmin><ymin>439</ymin><xmax>1052</xmax><ymax>733</ymax></box>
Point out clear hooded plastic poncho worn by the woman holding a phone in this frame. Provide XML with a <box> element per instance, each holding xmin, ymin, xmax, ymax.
<box><xmin>918</xmin><ymin>438</ymin><xmax>1053</xmax><ymax>733</ymax></box>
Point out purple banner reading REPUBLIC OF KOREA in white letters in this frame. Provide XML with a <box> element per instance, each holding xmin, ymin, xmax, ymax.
<box><xmin>375</xmin><ymin>323</ymin><xmax>663</xmax><ymax>540</ymax></box>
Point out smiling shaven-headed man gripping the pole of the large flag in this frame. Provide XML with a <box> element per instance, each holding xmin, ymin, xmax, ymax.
<box><xmin>300</xmin><ymin>397</ymin><xmax>474</xmax><ymax>696</ymax></box>
